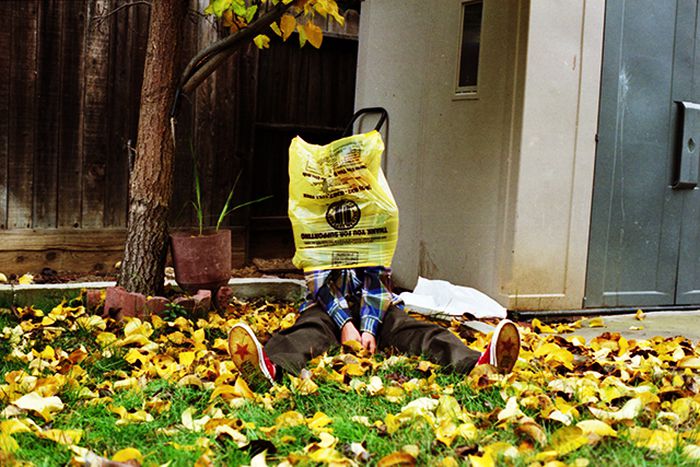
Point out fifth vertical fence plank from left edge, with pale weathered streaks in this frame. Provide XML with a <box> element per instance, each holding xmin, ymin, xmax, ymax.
<box><xmin>81</xmin><ymin>0</ymin><xmax>113</xmax><ymax>228</ymax></box>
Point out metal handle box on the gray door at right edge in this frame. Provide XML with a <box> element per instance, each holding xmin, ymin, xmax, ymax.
<box><xmin>673</xmin><ymin>101</ymin><xmax>700</xmax><ymax>190</ymax></box>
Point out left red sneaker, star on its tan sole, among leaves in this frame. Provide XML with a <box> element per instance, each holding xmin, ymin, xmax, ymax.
<box><xmin>228</xmin><ymin>323</ymin><xmax>277</xmax><ymax>391</ymax></box>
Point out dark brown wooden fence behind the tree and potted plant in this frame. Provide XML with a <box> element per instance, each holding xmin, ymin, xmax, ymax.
<box><xmin>0</xmin><ymin>0</ymin><xmax>358</xmax><ymax>273</ymax></box>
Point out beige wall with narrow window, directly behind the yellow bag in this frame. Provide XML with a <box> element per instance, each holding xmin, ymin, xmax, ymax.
<box><xmin>356</xmin><ymin>0</ymin><xmax>521</xmax><ymax>296</ymax></box>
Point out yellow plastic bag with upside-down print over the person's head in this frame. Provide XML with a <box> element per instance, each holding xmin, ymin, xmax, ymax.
<box><xmin>289</xmin><ymin>131</ymin><xmax>399</xmax><ymax>271</ymax></box>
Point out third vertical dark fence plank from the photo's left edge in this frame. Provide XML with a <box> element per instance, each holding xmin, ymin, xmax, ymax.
<box><xmin>33</xmin><ymin>0</ymin><xmax>64</xmax><ymax>229</ymax></box>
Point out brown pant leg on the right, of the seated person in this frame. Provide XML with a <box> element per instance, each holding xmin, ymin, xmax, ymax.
<box><xmin>377</xmin><ymin>307</ymin><xmax>480</xmax><ymax>373</ymax></box>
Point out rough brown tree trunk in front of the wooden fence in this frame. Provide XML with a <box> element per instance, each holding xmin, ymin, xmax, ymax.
<box><xmin>119</xmin><ymin>0</ymin><xmax>187</xmax><ymax>295</ymax></box>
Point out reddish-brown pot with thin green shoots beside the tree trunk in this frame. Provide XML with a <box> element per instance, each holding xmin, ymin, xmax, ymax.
<box><xmin>170</xmin><ymin>164</ymin><xmax>272</xmax><ymax>295</ymax></box>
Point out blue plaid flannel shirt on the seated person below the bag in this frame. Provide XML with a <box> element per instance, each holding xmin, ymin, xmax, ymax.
<box><xmin>300</xmin><ymin>266</ymin><xmax>403</xmax><ymax>336</ymax></box>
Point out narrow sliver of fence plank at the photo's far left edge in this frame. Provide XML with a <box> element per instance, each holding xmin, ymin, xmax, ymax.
<box><xmin>0</xmin><ymin>2</ymin><xmax>14</xmax><ymax>229</ymax></box>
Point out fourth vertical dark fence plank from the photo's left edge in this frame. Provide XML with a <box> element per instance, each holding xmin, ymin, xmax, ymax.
<box><xmin>58</xmin><ymin>2</ymin><xmax>86</xmax><ymax>228</ymax></box>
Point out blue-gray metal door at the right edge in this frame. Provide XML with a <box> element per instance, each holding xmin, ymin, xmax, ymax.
<box><xmin>584</xmin><ymin>0</ymin><xmax>700</xmax><ymax>307</ymax></box>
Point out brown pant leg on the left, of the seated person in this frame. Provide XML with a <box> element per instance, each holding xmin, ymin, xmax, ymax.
<box><xmin>265</xmin><ymin>305</ymin><xmax>340</xmax><ymax>375</ymax></box>
